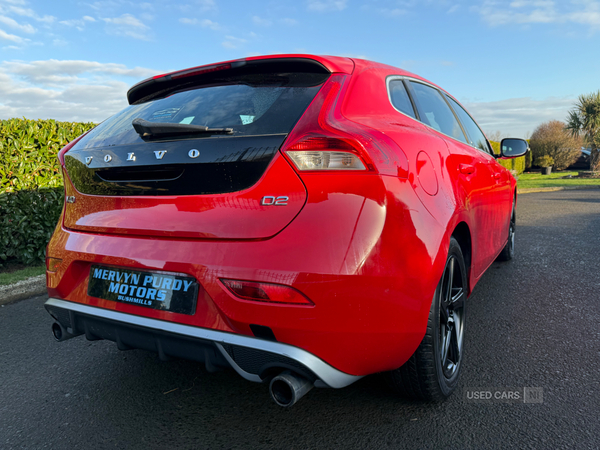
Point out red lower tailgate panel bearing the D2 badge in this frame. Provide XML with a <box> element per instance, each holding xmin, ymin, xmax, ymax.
<box><xmin>64</xmin><ymin>149</ymin><xmax>306</xmax><ymax>239</ymax></box>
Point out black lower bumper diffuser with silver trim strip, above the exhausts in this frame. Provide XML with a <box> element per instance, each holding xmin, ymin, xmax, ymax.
<box><xmin>45</xmin><ymin>298</ymin><xmax>362</xmax><ymax>388</ymax></box>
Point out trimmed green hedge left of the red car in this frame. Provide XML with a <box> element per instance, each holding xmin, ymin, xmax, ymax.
<box><xmin>0</xmin><ymin>119</ymin><xmax>95</xmax><ymax>266</ymax></box>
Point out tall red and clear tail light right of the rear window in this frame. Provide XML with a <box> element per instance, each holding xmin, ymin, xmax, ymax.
<box><xmin>282</xmin><ymin>74</ymin><xmax>408</xmax><ymax>177</ymax></box>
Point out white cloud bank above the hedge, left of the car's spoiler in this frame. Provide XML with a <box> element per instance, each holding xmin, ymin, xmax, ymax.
<box><xmin>0</xmin><ymin>60</ymin><xmax>157</xmax><ymax>122</ymax></box>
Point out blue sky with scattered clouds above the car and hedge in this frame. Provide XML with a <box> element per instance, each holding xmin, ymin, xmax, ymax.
<box><xmin>0</xmin><ymin>0</ymin><xmax>600</xmax><ymax>137</ymax></box>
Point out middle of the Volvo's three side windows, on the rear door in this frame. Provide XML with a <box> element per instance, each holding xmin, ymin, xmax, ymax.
<box><xmin>410</xmin><ymin>81</ymin><xmax>467</xmax><ymax>143</ymax></box>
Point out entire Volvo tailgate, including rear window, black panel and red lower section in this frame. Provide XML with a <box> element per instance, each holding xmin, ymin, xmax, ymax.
<box><xmin>63</xmin><ymin>59</ymin><xmax>338</xmax><ymax>239</ymax></box>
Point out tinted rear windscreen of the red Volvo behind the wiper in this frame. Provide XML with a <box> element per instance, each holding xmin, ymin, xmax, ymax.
<box><xmin>77</xmin><ymin>73</ymin><xmax>327</xmax><ymax>149</ymax></box>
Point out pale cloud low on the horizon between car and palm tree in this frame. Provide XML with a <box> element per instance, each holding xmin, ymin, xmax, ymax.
<box><xmin>462</xmin><ymin>97</ymin><xmax>577</xmax><ymax>138</ymax></box>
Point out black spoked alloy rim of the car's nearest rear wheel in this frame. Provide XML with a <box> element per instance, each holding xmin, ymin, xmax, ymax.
<box><xmin>440</xmin><ymin>256</ymin><xmax>466</xmax><ymax>378</ymax></box>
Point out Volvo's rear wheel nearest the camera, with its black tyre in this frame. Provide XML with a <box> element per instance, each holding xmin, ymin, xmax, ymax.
<box><xmin>387</xmin><ymin>237</ymin><xmax>467</xmax><ymax>401</ymax></box>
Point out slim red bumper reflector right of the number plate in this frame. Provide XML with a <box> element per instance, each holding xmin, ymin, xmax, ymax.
<box><xmin>221</xmin><ymin>278</ymin><xmax>314</xmax><ymax>306</ymax></box>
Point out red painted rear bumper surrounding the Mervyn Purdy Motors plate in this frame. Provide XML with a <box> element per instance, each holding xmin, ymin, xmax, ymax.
<box><xmin>47</xmin><ymin>175</ymin><xmax>445</xmax><ymax>376</ymax></box>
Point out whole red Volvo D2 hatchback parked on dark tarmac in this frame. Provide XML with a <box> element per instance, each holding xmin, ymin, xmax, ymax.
<box><xmin>46</xmin><ymin>55</ymin><xmax>527</xmax><ymax>406</ymax></box>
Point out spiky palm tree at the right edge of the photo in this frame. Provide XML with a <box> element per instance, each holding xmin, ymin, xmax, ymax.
<box><xmin>565</xmin><ymin>91</ymin><xmax>600</xmax><ymax>171</ymax></box>
